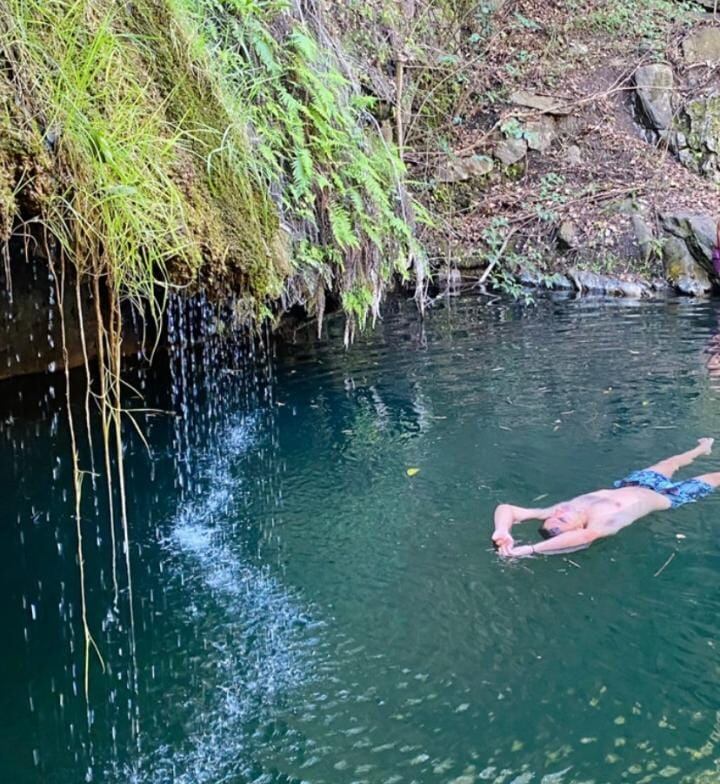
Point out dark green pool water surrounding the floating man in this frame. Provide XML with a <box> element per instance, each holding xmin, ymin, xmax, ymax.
<box><xmin>0</xmin><ymin>299</ymin><xmax>720</xmax><ymax>784</ymax></box>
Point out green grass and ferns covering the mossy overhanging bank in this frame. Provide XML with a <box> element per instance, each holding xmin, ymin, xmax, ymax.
<box><xmin>0</xmin><ymin>0</ymin><xmax>418</xmax><ymax>324</ymax></box>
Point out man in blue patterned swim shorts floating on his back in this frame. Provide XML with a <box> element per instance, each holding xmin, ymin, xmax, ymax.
<box><xmin>492</xmin><ymin>438</ymin><xmax>720</xmax><ymax>557</ymax></box>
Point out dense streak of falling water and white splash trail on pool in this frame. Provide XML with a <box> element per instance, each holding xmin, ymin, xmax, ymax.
<box><xmin>107</xmin><ymin>297</ymin><xmax>318</xmax><ymax>784</ymax></box>
